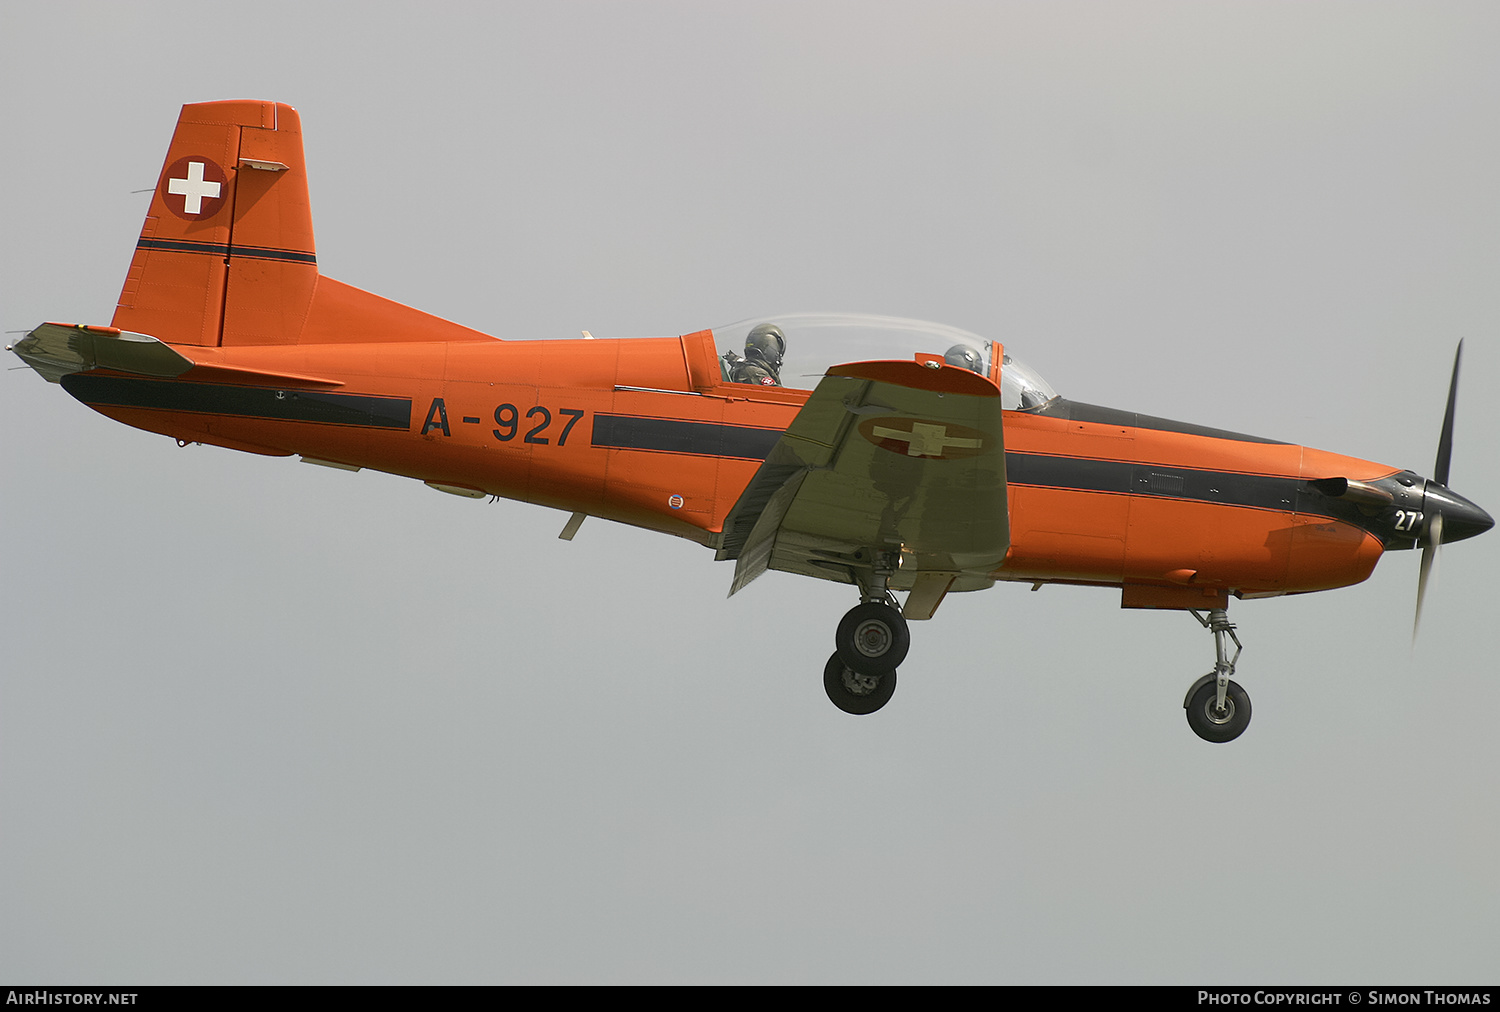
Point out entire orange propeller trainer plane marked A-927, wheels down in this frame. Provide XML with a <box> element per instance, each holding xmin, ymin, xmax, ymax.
<box><xmin>14</xmin><ymin>102</ymin><xmax>1494</xmax><ymax>742</ymax></box>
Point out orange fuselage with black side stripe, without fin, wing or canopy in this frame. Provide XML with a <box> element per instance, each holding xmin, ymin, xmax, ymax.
<box><xmin>63</xmin><ymin>331</ymin><xmax>1476</xmax><ymax>607</ymax></box>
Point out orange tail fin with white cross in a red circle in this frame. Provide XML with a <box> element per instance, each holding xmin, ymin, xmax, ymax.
<box><xmin>113</xmin><ymin>102</ymin><xmax>486</xmax><ymax>348</ymax></box>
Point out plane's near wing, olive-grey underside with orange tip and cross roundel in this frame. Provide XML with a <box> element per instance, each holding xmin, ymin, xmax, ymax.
<box><xmin>717</xmin><ymin>361</ymin><xmax>1010</xmax><ymax>618</ymax></box>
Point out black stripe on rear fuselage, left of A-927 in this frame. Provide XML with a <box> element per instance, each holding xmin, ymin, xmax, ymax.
<box><xmin>62</xmin><ymin>373</ymin><xmax>411</xmax><ymax>429</ymax></box>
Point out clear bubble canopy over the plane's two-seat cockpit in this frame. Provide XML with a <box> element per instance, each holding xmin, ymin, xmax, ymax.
<box><xmin>713</xmin><ymin>313</ymin><xmax>1058</xmax><ymax>411</ymax></box>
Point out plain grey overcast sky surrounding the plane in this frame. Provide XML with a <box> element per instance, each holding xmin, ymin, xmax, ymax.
<box><xmin>0</xmin><ymin>1</ymin><xmax>1500</xmax><ymax>984</ymax></box>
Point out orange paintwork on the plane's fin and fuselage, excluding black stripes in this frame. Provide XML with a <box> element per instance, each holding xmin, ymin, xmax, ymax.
<box><xmin>49</xmin><ymin>102</ymin><xmax>1397</xmax><ymax>607</ymax></box>
